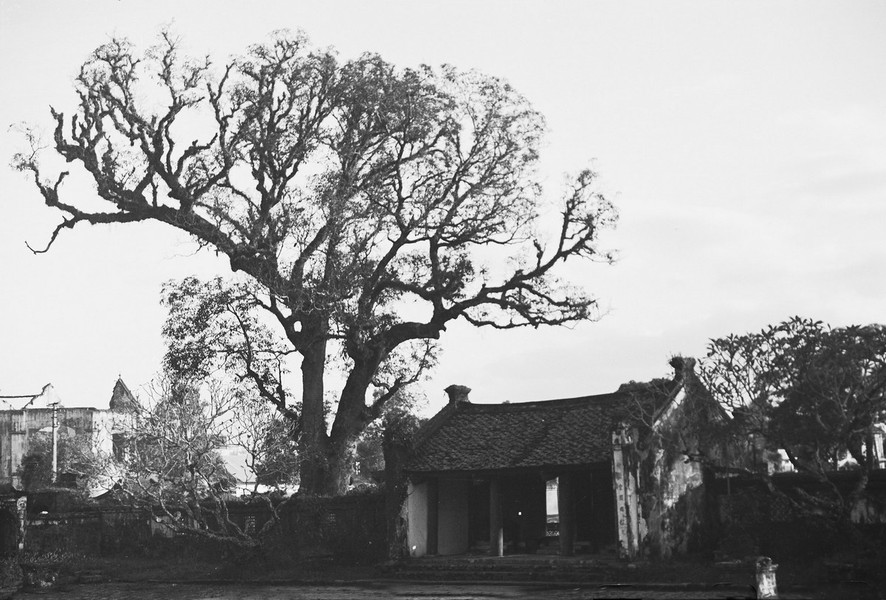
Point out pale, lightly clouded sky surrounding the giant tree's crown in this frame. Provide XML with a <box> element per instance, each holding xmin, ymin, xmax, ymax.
<box><xmin>0</xmin><ymin>0</ymin><xmax>886</xmax><ymax>412</ymax></box>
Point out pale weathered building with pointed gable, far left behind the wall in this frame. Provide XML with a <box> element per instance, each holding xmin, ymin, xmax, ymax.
<box><xmin>0</xmin><ymin>378</ymin><xmax>138</xmax><ymax>489</ymax></box>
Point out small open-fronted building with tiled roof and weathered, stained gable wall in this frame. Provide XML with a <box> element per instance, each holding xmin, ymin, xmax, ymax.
<box><xmin>404</xmin><ymin>359</ymin><xmax>723</xmax><ymax>558</ymax></box>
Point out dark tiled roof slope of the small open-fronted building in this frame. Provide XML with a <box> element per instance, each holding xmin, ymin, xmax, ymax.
<box><xmin>407</xmin><ymin>392</ymin><xmax>661</xmax><ymax>472</ymax></box>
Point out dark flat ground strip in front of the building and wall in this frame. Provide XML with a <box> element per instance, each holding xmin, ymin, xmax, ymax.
<box><xmin>16</xmin><ymin>553</ymin><xmax>886</xmax><ymax>600</ymax></box>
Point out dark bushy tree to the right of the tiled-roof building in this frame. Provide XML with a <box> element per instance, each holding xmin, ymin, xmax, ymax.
<box><xmin>700</xmin><ymin>317</ymin><xmax>886</xmax><ymax>513</ymax></box>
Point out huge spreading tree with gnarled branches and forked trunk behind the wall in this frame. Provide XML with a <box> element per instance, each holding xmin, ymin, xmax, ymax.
<box><xmin>17</xmin><ymin>33</ymin><xmax>615</xmax><ymax>493</ymax></box>
